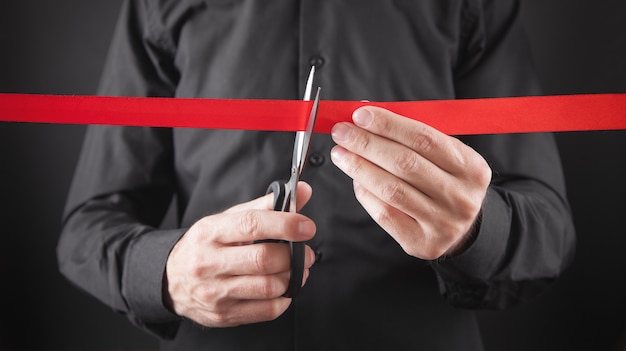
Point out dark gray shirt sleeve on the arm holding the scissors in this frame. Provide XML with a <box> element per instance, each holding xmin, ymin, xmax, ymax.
<box><xmin>57</xmin><ymin>1</ymin><xmax>185</xmax><ymax>337</ymax></box>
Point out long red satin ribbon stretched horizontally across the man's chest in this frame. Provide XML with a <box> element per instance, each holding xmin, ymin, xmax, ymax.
<box><xmin>0</xmin><ymin>94</ymin><xmax>626</xmax><ymax>135</ymax></box>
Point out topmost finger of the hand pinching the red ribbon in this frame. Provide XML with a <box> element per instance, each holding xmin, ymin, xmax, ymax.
<box><xmin>352</xmin><ymin>106</ymin><xmax>473</xmax><ymax>174</ymax></box>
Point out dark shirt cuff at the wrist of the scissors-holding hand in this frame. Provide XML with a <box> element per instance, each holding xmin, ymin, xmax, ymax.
<box><xmin>122</xmin><ymin>229</ymin><xmax>186</xmax><ymax>324</ymax></box>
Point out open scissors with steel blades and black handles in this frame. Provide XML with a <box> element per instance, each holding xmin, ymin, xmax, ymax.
<box><xmin>266</xmin><ymin>66</ymin><xmax>320</xmax><ymax>298</ymax></box>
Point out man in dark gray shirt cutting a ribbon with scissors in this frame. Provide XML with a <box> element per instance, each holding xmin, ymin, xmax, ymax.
<box><xmin>58</xmin><ymin>0</ymin><xmax>574</xmax><ymax>350</ymax></box>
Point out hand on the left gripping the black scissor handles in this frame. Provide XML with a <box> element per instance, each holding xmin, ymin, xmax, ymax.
<box><xmin>164</xmin><ymin>182</ymin><xmax>315</xmax><ymax>327</ymax></box>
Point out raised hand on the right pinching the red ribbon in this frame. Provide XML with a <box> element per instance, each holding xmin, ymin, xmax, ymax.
<box><xmin>331</xmin><ymin>106</ymin><xmax>491</xmax><ymax>260</ymax></box>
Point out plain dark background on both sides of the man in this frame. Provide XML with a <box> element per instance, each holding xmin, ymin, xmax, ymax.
<box><xmin>0</xmin><ymin>0</ymin><xmax>626</xmax><ymax>351</ymax></box>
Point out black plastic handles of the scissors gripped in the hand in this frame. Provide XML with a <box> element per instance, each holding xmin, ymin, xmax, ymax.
<box><xmin>266</xmin><ymin>180</ymin><xmax>304</xmax><ymax>298</ymax></box>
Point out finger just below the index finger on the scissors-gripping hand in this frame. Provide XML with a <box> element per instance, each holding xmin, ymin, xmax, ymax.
<box><xmin>214</xmin><ymin>242</ymin><xmax>315</xmax><ymax>276</ymax></box>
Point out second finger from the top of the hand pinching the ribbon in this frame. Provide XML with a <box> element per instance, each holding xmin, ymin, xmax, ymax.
<box><xmin>332</xmin><ymin>123</ymin><xmax>454</xmax><ymax>197</ymax></box>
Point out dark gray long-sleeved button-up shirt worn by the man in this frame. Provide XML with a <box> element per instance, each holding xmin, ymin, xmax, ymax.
<box><xmin>58</xmin><ymin>0</ymin><xmax>574</xmax><ymax>351</ymax></box>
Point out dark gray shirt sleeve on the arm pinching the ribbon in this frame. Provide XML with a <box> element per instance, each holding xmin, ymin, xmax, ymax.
<box><xmin>433</xmin><ymin>0</ymin><xmax>575</xmax><ymax>309</ymax></box>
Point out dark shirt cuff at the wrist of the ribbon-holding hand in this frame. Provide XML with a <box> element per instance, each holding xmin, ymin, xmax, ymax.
<box><xmin>433</xmin><ymin>188</ymin><xmax>511</xmax><ymax>283</ymax></box>
